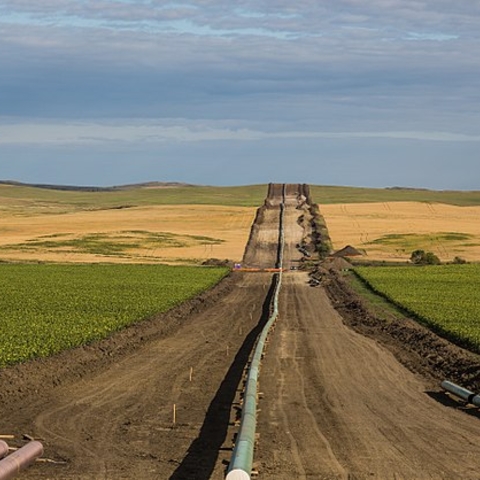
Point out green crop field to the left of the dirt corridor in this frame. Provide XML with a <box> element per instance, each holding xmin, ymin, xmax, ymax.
<box><xmin>0</xmin><ymin>264</ymin><xmax>227</xmax><ymax>367</ymax></box>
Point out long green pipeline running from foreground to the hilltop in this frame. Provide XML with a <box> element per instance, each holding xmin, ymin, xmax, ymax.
<box><xmin>226</xmin><ymin>185</ymin><xmax>286</xmax><ymax>480</ymax></box>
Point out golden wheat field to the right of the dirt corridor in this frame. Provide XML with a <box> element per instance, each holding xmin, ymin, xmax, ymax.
<box><xmin>320</xmin><ymin>202</ymin><xmax>480</xmax><ymax>262</ymax></box>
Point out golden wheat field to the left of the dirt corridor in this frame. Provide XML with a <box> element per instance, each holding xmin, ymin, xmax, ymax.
<box><xmin>0</xmin><ymin>205</ymin><xmax>256</xmax><ymax>264</ymax></box>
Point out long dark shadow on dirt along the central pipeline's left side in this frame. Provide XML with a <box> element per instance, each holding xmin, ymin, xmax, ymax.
<box><xmin>169</xmin><ymin>276</ymin><xmax>277</xmax><ymax>480</ymax></box>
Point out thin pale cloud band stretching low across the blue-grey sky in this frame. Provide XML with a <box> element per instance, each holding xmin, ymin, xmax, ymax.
<box><xmin>0</xmin><ymin>119</ymin><xmax>480</xmax><ymax>146</ymax></box>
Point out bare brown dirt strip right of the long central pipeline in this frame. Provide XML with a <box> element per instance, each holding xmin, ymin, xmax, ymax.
<box><xmin>256</xmin><ymin>273</ymin><xmax>480</xmax><ymax>479</ymax></box>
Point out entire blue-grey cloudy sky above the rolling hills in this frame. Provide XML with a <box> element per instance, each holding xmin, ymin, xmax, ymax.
<box><xmin>0</xmin><ymin>0</ymin><xmax>480</xmax><ymax>190</ymax></box>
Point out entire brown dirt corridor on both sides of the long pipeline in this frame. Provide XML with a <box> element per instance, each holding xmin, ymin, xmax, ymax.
<box><xmin>0</xmin><ymin>186</ymin><xmax>480</xmax><ymax>480</ymax></box>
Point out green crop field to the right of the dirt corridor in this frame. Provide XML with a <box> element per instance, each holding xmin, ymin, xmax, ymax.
<box><xmin>355</xmin><ymin>264</ymin><xmax>480</xmax><ymax>352</ymax></box>
